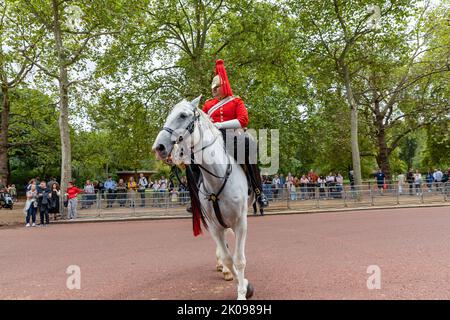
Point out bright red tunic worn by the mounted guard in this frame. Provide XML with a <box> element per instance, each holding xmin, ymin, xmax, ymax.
<box><xmin>203</xmin><ymin>97</ymin><xmax>248</xmax><ymax>128</ymax></box>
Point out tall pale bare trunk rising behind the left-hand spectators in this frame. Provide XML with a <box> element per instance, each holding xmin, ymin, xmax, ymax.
<box><xmin>52</xmin><ymin>0</ymin><xmax>72</xmax><ymax>216</ymax></box>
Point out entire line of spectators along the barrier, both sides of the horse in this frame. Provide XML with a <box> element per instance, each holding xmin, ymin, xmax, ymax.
<box><xmin>0</xmin><ymin>169</ymin><xmax>450</xmax><ymax>227</ymax></box>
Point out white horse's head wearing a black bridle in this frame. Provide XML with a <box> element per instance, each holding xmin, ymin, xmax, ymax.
<box><xmin>152</xmin><ymin>96</ymin><xmax>201</xmax><ymax>161</ymax></box>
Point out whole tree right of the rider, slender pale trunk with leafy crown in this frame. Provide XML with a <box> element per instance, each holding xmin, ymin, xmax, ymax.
<box><xmin>288</xmin><ymin>0</ymin><xmax>418</xmax><ymax>185</ymax></box>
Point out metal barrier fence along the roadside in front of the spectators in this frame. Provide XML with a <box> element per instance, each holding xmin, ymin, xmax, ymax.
<box><xmin>64</xmin><ymin>183</ymin><xmax>450</xmax><ymax>218</ymax></box>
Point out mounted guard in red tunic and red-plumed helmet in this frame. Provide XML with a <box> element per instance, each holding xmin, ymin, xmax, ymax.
<box><xmin>188</xmin><ymin>60</ymin><xmax>268</xmax><ymax>211</ymax></box>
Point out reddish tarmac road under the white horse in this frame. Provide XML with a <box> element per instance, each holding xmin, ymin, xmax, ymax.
<box><xmin>0</xmin><ymin>206</ymin><xmax>450</xmax><ymax>300</ymax></box>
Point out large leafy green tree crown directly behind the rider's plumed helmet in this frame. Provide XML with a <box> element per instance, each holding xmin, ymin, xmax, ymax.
<box><xmin>96</xmin><ymin>0</ymin><xmax>304</xmax><ymax>174</ymax></box>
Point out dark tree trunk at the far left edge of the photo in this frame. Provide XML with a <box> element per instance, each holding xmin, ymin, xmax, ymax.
<box><xmin>0</xmin><ymin>85</ymin><xmax>10</xmax><ymax>185</ymax></box>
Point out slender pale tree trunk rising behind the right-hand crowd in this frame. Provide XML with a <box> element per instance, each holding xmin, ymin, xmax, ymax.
<box><xmin>342</xmin><ymin>64</ymin><xmax>362</xmax><ymax>190</ymax></box>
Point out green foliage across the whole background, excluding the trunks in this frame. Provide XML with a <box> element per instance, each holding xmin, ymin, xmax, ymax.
<box><xmin>2</xmin><ymin>0</ymin><xmax>450</xmax><ymax>182</ymax></box>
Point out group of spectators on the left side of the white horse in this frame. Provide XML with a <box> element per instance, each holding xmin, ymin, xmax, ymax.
<box><xmin>16</xmin><ymin>173</ymin><xmax>188</xmax><ymax>227</ymax></box>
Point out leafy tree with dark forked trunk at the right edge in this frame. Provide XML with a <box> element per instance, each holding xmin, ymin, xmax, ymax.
<box><xmin>356</xmin><ymin>3</ymin><xmax>450</xmax><ymax>178</ymax></box>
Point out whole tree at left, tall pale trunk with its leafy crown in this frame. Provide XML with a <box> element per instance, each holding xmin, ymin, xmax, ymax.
<box><xmin>19</xmin><ymin>0</ymin><xmax>121</xmax><ymax>212</ymax></box>
